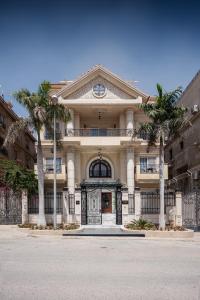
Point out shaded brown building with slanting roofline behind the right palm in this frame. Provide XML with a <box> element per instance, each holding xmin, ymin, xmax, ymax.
<box><xmin>165</xmin><ymin>71</ymin><xmax>200</xmax><ymax>193</ymax></box>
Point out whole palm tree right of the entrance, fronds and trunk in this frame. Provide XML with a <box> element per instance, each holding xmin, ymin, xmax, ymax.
<box><xmin>140</xmin><ymin>84</ymin><xmax>186</xmax><ymax>230</ymax></box>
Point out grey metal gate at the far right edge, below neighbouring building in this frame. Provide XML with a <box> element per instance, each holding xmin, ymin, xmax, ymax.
<box><xmin>182</xmin><ymin>190</ymin><xmax>200</xmax><ymax>230</ymax></box>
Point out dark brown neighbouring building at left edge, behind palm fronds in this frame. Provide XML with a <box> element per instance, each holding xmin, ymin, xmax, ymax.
<box><xmin>0</xmin><ymin>96</ymin><xmax>36</xmax><ymax>169</ymax></box>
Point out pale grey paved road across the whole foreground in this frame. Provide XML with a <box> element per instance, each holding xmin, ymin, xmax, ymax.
<box><xmin>0</xmin><ymin>226</ymin><xmax>200</xmax><ymax>300</ymax></box>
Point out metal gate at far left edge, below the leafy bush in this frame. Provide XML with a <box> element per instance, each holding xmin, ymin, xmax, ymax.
<box><xmin>0</xmin><ymin>188</ymin><xmax>22</xmax><ymax>225</ymax></box>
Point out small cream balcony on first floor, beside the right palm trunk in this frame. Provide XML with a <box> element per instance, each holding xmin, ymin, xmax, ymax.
<box><xmin>135</xmin><ymin>164</ymin><xmax>168</xmax><ymax>181</ymax></box>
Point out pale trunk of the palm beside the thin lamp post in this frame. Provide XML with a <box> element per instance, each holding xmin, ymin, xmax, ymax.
<box><xmin>37</xmin><ymin>132</ymin><xmax>46</xmax><ymax>226</ymax></box>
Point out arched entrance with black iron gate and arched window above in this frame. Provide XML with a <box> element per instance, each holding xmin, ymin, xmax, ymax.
<box><xmin>81</xmin><ymin>159</ymin><xmax>122</xmax><ymax>225</ymax></box>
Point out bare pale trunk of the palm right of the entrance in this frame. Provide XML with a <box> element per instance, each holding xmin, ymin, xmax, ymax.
<box><xmin>159</xmin><ymin>134</ymin><xmax>165</xmax><ymax>230</ymax></box>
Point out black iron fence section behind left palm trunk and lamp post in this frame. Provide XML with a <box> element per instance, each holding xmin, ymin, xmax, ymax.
<box><xmin>28</xmin><ymin>192</ymin><xmax>63</xmax><ymax>214</ymax></box>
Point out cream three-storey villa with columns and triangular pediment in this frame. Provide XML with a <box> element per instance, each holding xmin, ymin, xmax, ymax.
<box><xmin>29</xmin><ymin>66</ymin><xmax>167</xmax><ymax>225</ymax></box>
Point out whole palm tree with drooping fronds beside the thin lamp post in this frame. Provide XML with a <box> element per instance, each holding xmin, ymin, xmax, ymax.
<box><xmin>4</xmin><ymin>81</ymin><xmax>70</xmax><ymax>226</ymax></box>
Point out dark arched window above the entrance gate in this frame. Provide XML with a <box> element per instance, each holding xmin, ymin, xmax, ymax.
<box><xmin>89</xmin><ymin>159</ymin><xmax>111</xmax><ymax>178</ymax></box>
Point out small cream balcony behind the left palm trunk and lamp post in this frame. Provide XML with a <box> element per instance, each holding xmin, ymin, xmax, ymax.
<box><xmin>35</xmin><ymin>164</ymin><xmax>66</xmax><ymax>182</ymax></box>
